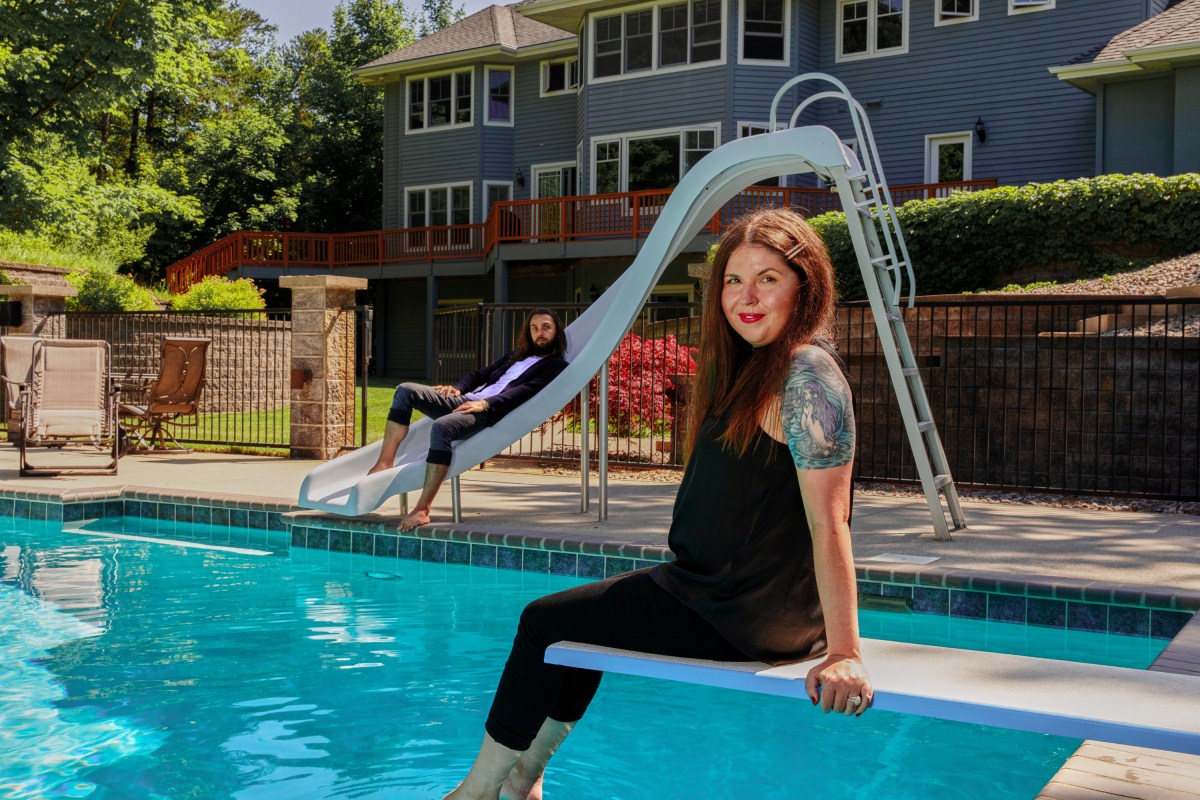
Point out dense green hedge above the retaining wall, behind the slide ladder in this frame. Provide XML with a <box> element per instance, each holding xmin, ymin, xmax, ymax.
<box><xmin>809</xmin><ymin>173</ymin><xmax>1200</xmax><ymax>300</ymax></box>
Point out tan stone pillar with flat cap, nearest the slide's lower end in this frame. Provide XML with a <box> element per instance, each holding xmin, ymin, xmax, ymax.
<box><xmin>280</xmin><ymin>275</ymin><xmax>367</xmax><ymax>459</ymax></box>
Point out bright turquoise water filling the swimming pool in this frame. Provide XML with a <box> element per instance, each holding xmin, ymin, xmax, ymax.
<box><xmin>0</xmin><ymin>518</ymin><xmax>1165</xmax><ymax>800</ymax></box>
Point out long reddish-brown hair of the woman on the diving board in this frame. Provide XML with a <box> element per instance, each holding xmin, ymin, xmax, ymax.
<box><xmin>688</xmin><ymin>209</ymin><xmax>836</xmax><ymax>453</ymax></box>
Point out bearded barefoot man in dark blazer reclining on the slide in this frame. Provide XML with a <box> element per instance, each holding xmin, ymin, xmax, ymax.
<box><xmin>367</xmin><ymin>308</ymin><xmax>566</xmax><ymax>530</ymax></box>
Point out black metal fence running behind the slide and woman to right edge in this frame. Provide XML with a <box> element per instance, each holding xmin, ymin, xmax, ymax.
<box><xmin>434</xmin><ymin>295</ymin><xmax>1200</xmax><ymax>500</ymax></box>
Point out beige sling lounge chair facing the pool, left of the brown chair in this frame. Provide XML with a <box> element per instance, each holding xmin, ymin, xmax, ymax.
<box><xmin>20</xmin><ymin>339</ymin><xmax>120</xmax><ymax>476</ymax></box>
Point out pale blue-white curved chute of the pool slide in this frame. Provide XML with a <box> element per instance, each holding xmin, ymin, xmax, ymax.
<box><xmin>299</xmin><ymin>126</ymin><xmax>860</xmax><ymax>516</ymax></box>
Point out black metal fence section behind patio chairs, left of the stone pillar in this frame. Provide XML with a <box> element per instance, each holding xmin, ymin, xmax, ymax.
<box><xmin>65</xmin><ymin>308</ymin><xmax>292</xmax><ymax>449</ymax></box>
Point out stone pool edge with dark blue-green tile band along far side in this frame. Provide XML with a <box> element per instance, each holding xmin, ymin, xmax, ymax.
<box><xmin>0</xmin><ymin>486</ymin><xmax>1200</xmax><ymax>639</ymax></box>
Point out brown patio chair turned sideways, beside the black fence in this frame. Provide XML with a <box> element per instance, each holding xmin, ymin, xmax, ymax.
<box><xmin>120</xmin><ymin>337</ymin><xmax>210</xmax><ymax>453</ymax></box>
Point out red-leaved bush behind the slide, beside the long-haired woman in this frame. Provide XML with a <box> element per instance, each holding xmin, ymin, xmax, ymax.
<box><xmin>563</xmin><ymin>333</ymin><xmax>696</xmax><ymax>437</ymax></box>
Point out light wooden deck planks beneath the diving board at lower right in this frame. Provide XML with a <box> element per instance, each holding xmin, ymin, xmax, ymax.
<box><xmin>1038</xmin><ymin>615</ymin><xmax>1200</xmax><ymax>800</ymax></box>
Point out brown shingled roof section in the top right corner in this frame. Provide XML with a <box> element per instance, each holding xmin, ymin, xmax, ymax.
<box><xmin>1050</xmin><ymin>0</ymin><xmax>1200</xmax><ymax>92</ymax></box>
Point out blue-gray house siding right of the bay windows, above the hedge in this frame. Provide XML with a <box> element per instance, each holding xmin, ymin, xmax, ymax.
<box><xmin>822</xmin><ymin>0</ymin><xmax>1144</xmax><ymax>184</ymax></box>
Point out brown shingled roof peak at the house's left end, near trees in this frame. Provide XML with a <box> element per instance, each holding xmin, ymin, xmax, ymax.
<box><xmin>358</xmin><ymin>6</ymin><xmax>575</xmax><ymax>72</ymax></box>
